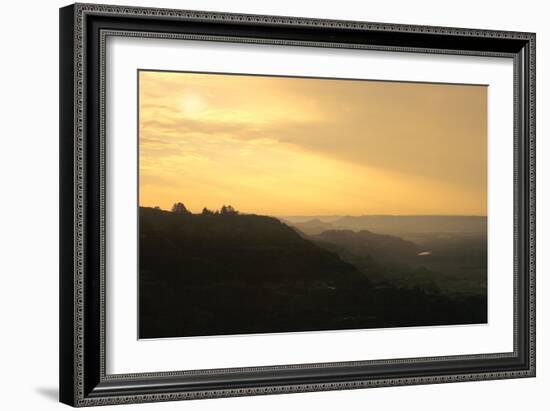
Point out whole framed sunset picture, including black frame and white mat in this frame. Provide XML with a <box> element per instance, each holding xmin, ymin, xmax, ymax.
<box><xmin>60</xmin><ymin>4</ymin><xmax>535</xmax><ymax>406</ymax></box>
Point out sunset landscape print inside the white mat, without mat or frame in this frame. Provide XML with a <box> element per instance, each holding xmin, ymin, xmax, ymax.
<box><xmin>139</xmin><ymin>69</ymin><xmax>488</xmax><ymax>339</ymax></box>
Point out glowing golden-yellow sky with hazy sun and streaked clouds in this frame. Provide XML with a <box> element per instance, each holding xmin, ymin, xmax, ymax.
<box><xmin>139</xmin><ymin>71</ymin><xmax>487</xmax><ymax>216</ymax></box>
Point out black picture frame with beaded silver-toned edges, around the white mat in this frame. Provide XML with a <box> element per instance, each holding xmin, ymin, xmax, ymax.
<box><xmin>60</xmin><ymin>4</ymin><xmax>535</xmax><ymax>406</ymax></box>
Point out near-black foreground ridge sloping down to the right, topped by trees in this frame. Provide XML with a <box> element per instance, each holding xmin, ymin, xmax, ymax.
<box><xmin>139</xmin><ymin>208</ymin><xmax>487</xmax><ymax>338</ymax></box>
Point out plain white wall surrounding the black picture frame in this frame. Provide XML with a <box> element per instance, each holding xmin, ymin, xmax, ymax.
<box><xmin>0</xmin><ymin>0</ymin><xmax>550</xmax><ymax>410</ymax></box>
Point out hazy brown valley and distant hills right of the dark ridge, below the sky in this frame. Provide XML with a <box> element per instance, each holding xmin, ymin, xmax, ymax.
<box><xmin>281</xmin><ymin>215</ymin><xmax>487</xmax><ymax>294</ymax></box>
